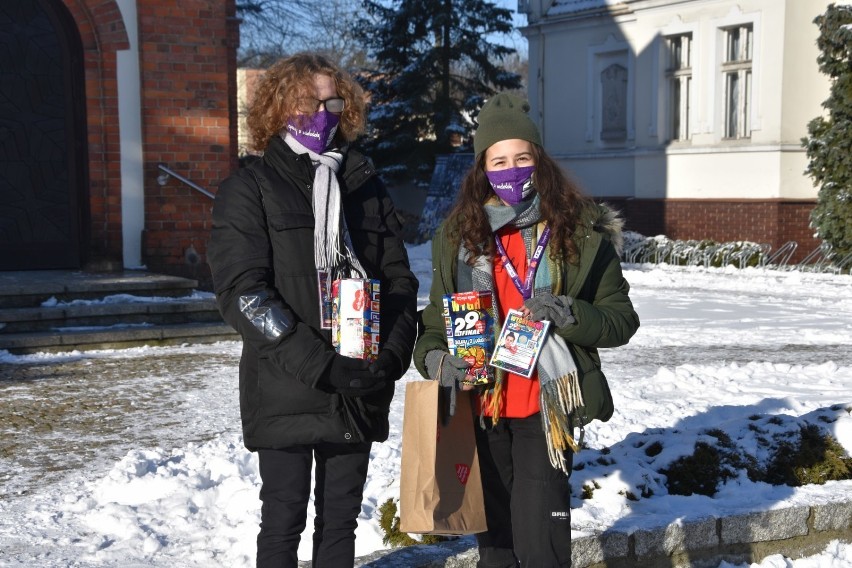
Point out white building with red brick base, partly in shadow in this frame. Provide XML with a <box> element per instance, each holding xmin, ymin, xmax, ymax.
<box><xmin>518</xmin><ymin>0</ymin><xmax>830</xmax><ymax>254</ymax></box>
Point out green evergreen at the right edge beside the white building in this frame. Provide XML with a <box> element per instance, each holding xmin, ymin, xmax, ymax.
<box><xmin>802</xmin><ymin>4</ymin><xmax>852</xmax><ymax>259</ymax></box>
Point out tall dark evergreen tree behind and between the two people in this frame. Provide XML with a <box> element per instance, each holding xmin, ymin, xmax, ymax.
<box><xmin>360</xmin><ymin>0</ymin><xmax>522</xmax><ymax>183</ymax></box>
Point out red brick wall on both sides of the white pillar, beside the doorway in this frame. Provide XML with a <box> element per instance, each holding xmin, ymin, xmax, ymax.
<box><xmin>63</xmin><ymin>0</ymin><xmax>239</xmax><ymax>287</ymax></box>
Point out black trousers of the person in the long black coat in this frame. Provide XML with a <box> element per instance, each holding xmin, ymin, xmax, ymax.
<box><xmin>257</xmin><ymin>443</ymin><xmax>370</xmax><ymax>568</ymax></box>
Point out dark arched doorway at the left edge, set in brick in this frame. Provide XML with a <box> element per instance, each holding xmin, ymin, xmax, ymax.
<box><xmin>0</xmin><ymin>0</ymin><xmax>89</xmax><ymax>270</ymax></box>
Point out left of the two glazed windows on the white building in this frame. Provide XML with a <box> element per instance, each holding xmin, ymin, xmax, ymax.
<box><xmin>666</xmin><ymin>34</ymin><xmax>692</xmax><ymax>140</ymax></box>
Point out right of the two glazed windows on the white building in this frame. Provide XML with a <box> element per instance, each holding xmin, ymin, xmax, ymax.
<box><xmin>722</xmin><ymin>24</ymin><xmax>754</xmax><ymax>139</ymax></box>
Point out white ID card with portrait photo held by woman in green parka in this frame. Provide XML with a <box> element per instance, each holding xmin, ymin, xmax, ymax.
<box><xmin>491</xmin><ymin>310</ymin><xmax>550</xmax><ymax>378</ymax></box>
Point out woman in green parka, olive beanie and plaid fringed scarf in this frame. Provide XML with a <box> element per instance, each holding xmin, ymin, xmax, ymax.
<box><xmin>414</xmin><ymin>93</ymin><xmax>639</xmax><ymax>568</ymax></box>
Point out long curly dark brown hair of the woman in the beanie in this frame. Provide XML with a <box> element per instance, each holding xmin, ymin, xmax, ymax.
<box><xmin>446</xmin><ymin>143</ymin><xmax>593</xmax><ymax>266</ymax></box>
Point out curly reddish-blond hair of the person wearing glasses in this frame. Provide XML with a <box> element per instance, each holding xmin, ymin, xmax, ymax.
<box><xmin>246</xmin><ymin>53</ymin><xmax>366</xmax><ymax>151</ymax></box>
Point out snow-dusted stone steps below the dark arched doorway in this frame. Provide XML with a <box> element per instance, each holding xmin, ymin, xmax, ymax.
<box><xmin>0</xmin><ymin>270</ymin><xmax>239</xmax><ymax>354</ymax></box>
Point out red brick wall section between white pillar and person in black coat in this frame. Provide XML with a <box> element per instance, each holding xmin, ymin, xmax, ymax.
<box><xmin>138</xmin><ymin>0</ymin><xmax>239</xmax><ymax>287</ymax></box>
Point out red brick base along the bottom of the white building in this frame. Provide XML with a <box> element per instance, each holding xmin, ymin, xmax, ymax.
<box><xmin>601</xmin><ymin>198</ymin><xmax>820</xmax><ymax>262</ymax></box>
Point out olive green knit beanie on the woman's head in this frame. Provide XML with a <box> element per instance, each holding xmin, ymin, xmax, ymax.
<box><xmin>473</xmin><ymin>93</ymin><xmax>542</xmax><ymax>157</ymax></box>
